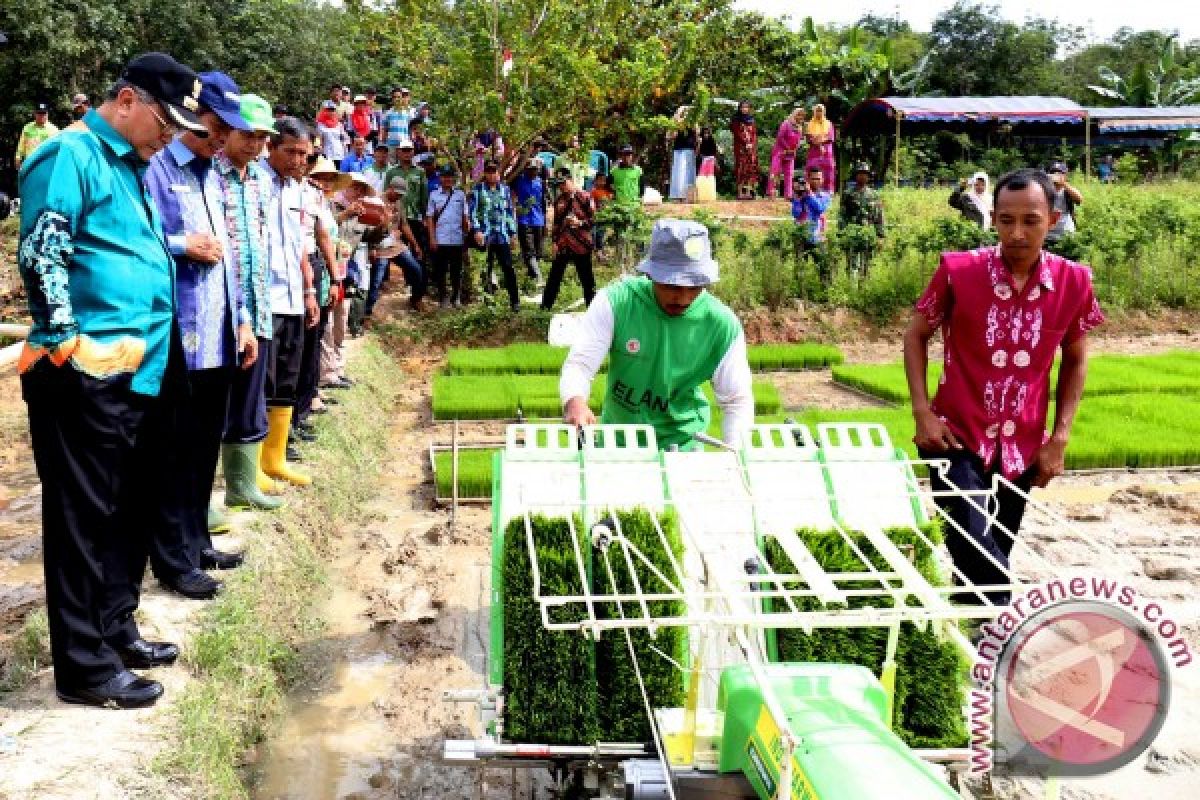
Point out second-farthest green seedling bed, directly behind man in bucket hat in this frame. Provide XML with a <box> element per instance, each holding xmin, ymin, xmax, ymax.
<box><xmin>433</xmin><ymin>374</ymin><xmax>782</xmax><ymax>420</ymax></box>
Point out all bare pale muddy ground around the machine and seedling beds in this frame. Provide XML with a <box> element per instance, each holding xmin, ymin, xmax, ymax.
<box><xmin>0</xmin><ymin>321</ymin><xmax>1200</xmax><ymax>800</ymax></box>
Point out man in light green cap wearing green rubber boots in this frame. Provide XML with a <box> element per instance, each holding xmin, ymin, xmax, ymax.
<box><xmin>214</xmin><ymin>95</ymin><xmax>280</xmax><ymax>510</ymax></box>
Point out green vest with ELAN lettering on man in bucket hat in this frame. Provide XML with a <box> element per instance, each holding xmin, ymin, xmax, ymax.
<box><xmin>600</xmin><ymin>276</ymin><xmax>740</xmax><ymax>449</ymax></box>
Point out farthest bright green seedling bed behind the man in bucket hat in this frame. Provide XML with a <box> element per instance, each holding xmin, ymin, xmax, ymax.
<box><xmin>445</xmin><ymin>342</ymin><xmax>842</xmax><ymax>375</ymax></box>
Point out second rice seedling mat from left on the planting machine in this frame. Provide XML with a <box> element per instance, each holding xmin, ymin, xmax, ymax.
<box><xmin>592</xmin><ymin>510</ymin><xmax>688</xmax><ymax>741</ymax></box>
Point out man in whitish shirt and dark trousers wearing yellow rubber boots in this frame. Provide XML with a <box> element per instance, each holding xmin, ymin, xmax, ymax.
<box><xmin>259</xmin><ymin>116</ymin><xmax>320</xmax><ymax>486</ymax></box>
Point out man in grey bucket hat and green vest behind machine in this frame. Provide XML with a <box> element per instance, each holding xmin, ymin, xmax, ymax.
<box><xmin>559</xmin><ymin>219</ymin><xmax>754</xmax><ymax>449</ymax></box>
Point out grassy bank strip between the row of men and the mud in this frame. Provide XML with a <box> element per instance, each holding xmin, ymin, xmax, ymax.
<box><xmin>156</xmin><ymin>339</ymin><xmax>401</xmax><ymax>799</ymax></box>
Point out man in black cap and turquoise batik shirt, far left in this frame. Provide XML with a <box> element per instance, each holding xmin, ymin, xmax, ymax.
<box><xmin>18</xmin><ymin>53</ymin><xmax>204</xmax><ymax>708</ymax></box>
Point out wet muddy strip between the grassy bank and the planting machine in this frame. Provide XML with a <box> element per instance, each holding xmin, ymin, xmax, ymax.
<box><xmin>249</xmin><ymin>363</ymin><xmax>530</xmax><ymax>800</ymax></box>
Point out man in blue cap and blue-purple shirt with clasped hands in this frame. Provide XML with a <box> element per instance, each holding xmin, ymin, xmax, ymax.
<box><xmin>146</xmin><ymin>72</ymin><xmax>258</xmax><ymax>600</ymax></box>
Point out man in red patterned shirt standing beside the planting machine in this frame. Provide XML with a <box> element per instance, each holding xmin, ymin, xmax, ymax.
<box><xmin>904</xmin><ymin>169</ymin><xmax>1104</xmax><ymax>604</ymax></box>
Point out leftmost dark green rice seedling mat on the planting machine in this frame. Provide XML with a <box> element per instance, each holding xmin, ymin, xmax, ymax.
<box><xmin>502</xmin><ymin>516</ymin><xmax>598</xmax><ymax>745</ymax></box>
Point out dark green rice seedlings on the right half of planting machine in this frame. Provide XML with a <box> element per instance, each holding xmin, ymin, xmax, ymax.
<box><xmin>763</xmin><ymin>524</ymin><xmax>966</xmax><ymax>747</ymax></box>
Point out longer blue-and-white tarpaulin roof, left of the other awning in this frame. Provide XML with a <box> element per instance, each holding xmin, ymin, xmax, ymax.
<box><xmin>844</xmin><ymin>97</ymin><xmax>1087</xmax><ymax>132</ymax></box>
